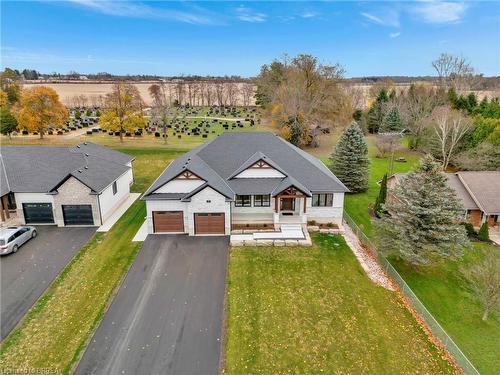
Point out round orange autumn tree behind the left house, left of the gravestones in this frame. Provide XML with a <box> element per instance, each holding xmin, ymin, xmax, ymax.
<box><xmin>15</xmin><ymin>86</ymin><xmax>68</xmax><ymax>138</ymax></box>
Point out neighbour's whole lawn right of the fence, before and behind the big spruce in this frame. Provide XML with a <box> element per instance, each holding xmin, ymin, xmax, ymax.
<box><xmin>324</xmin><ymin>137</ymin><xmax>500</xmax><ymax>374</ymax></box>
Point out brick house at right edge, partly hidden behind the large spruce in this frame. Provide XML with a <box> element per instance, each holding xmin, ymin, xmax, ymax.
<box><xmin>387</xmin><ymin>171</ymin><xmax>500</xmax><ymax>227</ymax></box>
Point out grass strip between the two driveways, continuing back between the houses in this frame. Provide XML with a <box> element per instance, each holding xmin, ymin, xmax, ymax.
<box><xmin>0</xmin><ymin>149</ymin><xmax>177</xmax><ymax>373</ymax></box>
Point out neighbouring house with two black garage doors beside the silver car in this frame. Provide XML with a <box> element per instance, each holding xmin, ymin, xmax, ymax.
<box><xmin>0</xmin><ymin>142</ymin><xmax>134</xmax><ymax>226</ymax></box>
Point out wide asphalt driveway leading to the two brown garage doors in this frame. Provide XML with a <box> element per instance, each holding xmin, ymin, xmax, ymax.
<box><xmin>76</xmin><ymin>235</ymin><xmax>229</xmax><ymax>375</ymax></box>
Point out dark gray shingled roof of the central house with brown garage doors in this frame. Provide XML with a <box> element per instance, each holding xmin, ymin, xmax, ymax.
<box><xmin>144</xmin><ymin>132</ymin><xmax>348</xmax><ymax>203</ymax></box>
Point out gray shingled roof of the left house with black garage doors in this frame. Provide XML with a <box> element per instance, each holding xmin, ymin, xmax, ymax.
<box><xmin>0</xmin><ymin>143</ymin><xmax>133</xmax><ymax>195</ymax></box>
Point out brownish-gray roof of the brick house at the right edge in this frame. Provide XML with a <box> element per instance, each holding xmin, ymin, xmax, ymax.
<box><xmin>457</xmin><ymin>171</ymin><xmax>500</xmax><ymax>215</ymax></box>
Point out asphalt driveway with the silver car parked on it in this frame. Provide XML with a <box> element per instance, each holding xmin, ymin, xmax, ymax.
<box><xmin>0</xmin><ymin>226</ymin><xmax>95</xmax><ymax>340</ymax></box>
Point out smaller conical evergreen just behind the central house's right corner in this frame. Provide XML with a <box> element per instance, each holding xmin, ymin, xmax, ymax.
<box><xmin>330</xmin><ymin>121</ymin><xmax>370</xmax><ymax>193</ymax></box>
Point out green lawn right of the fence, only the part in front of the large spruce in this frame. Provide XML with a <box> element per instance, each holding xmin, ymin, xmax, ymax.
<box><xmin>392</xmin><ymin>242</ymin><xmax>500</xmax><ymax>375</ymax></box>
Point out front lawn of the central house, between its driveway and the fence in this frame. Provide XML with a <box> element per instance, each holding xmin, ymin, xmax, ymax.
<box><xmin>225</xmin><ymin>234</ymin><xmax>454</xmax><ymax>374</ymax></box>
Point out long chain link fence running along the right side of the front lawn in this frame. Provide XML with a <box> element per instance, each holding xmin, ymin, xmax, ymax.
<box><xmin>344</xmin><ymin>211</ymin><xmax>479</xmax><ymax>375</ymax></box>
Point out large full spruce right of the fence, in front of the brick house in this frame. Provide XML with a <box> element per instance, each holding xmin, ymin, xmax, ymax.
<box><xmin>375</xmin><ymin>155</ymin><xmax>469</xmax><ymax>267</ymax></box>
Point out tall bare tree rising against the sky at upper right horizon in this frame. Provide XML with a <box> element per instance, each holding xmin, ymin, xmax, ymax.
<box><xmin>432</xmin><ymin>53</ymin><xmax>481</xmax><ymax>92</ymax></box>
